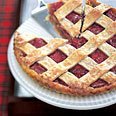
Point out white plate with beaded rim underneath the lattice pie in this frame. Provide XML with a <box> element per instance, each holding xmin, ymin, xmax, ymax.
<box><xmin>8</xmin><ymin>5</ymin><xmax>116</xmax><ymax>110</ymax></box>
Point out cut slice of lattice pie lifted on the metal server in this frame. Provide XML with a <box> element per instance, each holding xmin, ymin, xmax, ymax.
<box><xmin>48</xmin><ymin>0</ymin><xmax>84</xmax><ymax>39</ymax></box>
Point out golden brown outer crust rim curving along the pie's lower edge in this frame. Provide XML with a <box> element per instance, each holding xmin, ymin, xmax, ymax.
<box><xmin>14</xmin><ymin>31</ymin><xmax>116</xmax><ymax>96</ymax></box>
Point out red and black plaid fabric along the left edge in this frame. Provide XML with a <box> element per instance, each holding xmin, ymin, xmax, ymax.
<box><xmin>0</xmin><ymin>0</ymin><xmax>20</xmax><ymax>116</ymax></box>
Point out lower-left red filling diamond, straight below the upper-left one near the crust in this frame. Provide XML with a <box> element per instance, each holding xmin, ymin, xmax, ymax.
<box><xmin>30</xmin><ymin>62</ymin><xmax>47</xmax><ymax>74</ymax></box>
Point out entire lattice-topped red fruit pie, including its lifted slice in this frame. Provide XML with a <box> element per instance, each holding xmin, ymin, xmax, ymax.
<box><xmin>14</xmin><ymin>0</ymin><xmax>116</xmax><ymax>96</ymax></box>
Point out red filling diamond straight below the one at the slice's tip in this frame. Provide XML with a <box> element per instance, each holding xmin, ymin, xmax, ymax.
<box><xmin>69</xmin><ymin>64</ymin><xmax>88</xmax><ymax>78</ymax></box>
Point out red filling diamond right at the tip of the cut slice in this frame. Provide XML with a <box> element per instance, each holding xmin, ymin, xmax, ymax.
<box><xmin>69</xmin><ymin>37</ymin><xmax>87</xmax><ymax>48</ymax></box>
